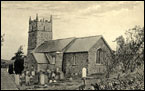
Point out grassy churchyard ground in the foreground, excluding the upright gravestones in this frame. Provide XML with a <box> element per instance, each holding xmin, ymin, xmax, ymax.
<box><xmin>16</xmin><ymin>72</ymin><xmax>103</xmax><ymax>90</ymax></box>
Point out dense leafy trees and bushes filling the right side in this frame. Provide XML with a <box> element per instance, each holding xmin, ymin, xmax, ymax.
<box><xmin>92</xmin><ymin>26</ymin><xmax>144</xmax><ymax>90</ymax></box>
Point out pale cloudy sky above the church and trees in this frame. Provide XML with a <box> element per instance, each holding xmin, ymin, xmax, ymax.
<box><xmin>1</xmin><ymin>1</ymin><xmax>144</xmax><ymax>60</ymax></box>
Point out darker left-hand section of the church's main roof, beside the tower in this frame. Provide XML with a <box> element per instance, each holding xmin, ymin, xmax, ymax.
<box><xmin>35</xmin><ymin>38</ymin><xmax>75</xmax><ymax>53</ymax></box>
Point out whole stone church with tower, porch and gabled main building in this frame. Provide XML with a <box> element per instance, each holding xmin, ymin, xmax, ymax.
<box><xmin>25</xmin><ymin>15</ymin><xmax>112</xmax><ymax>76</ymax></box>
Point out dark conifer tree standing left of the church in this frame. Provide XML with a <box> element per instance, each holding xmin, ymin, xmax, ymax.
<box><xmin>12</xmin><ymin>46</ymin><xmax>24</xmax><ymax>74</ymax></box>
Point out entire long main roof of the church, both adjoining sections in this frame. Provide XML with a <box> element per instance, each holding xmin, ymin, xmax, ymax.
<box><xmin>35</xmin><ymin>35</ymin><xmax>102</xmax><ymax>53</ymax></box>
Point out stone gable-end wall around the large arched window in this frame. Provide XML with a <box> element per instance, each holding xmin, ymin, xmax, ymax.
<box><xmin>88</xmin><ymin>39</ymin><xmax>111</xmax><ymax>74</ymax></box>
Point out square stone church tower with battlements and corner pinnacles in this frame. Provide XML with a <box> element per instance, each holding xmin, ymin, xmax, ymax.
<box><xmin>28</xmin><ymin>14</ymin><xmax>52</xmax><ymax>54</ymax></box>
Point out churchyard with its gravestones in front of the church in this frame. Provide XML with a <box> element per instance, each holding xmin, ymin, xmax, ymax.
<box><xmin>14</xmin><ymin>67</ymin><xmax>101</xmax><ymax>90</ymax></box>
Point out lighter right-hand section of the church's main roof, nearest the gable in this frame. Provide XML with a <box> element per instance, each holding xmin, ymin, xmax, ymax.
<box><xmin>65</xmin><ymin>35</ymin><xmax>102</xmax><ymax>53</ymax></box>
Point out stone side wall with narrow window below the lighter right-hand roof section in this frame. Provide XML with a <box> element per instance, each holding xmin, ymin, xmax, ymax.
<box><xmin>63</xmin><ymin>53</ymin><xmax>88</xmax><ymax>77</ymax></box>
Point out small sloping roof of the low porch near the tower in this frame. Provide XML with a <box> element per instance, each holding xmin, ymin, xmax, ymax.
<box><xmin>32</xmin><ymin>53</ymin><xmax>48</xmax><ymax>64</ymax></box>
